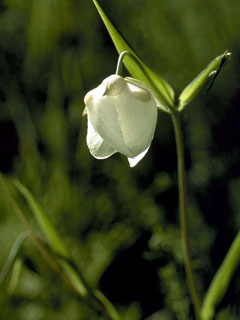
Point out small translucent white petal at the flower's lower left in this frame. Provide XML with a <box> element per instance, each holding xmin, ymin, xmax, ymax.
<box><xmin>87</xmin><ymin>117</ymin><xmax>117</xmax><ymax>159</ymax></box>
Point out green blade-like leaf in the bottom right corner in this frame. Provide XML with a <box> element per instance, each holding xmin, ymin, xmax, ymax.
<box><xmin>201</xmin><ymin>231</ymin><xmax>240</xmax><ymax>320</ymax></box>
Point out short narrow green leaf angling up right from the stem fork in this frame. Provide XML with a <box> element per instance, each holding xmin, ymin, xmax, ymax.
<box><xmin>179</xmin><ymin>51</ymin><xmax>231</xmax><ymax>111</ymax></box>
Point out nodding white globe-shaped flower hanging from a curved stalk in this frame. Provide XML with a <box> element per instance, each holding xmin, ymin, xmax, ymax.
<box><xmin>84</xmin><ymin>74</ymin><xmax>157</xmax><ymax>167</ymax></box>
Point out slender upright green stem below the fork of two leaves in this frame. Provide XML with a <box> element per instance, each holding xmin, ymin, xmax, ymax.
<box><xmin>171</xmin><ymin>111</ymin><xmax>201</xmax><ymax>320</ymax></box>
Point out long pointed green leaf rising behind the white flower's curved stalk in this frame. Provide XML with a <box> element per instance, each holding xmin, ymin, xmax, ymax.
<box><xmin>93</xmin><ymin>0</ymin><xmax>174</xmax><ymax>108</ymax></box>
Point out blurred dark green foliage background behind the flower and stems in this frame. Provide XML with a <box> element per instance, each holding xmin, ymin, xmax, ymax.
<box><xmin>0</xmin><ymin>0</ymin><xmax>240</xmax><ymax>320</ymax></box>
